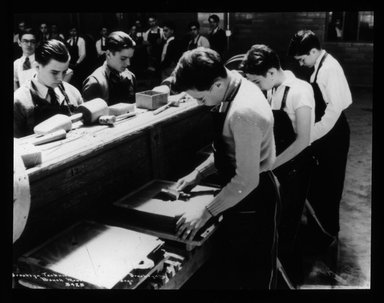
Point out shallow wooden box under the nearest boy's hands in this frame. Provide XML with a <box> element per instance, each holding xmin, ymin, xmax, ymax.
<box><xmin>110</xmin><ymin>180</ymin><xmax>221</xmax><ymax>246</ymax></box>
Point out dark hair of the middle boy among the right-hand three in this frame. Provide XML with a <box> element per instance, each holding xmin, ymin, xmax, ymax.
<box><xmin>240</xmin><ymin>44</ymin><xmax>281</xmax><ymax>76</ymax></box>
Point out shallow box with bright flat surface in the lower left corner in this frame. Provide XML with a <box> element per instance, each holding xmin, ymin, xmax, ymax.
<box><xmin>15</xmin><ymin>221</ymin><xmax>165</xmax><ymax>289</ymax></box>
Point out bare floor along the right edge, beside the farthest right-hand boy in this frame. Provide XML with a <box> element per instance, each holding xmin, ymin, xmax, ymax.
<box><xmin>299</xmin><ymin>89</ymin><xmax>373</xmax><ymax>289</ymax></box>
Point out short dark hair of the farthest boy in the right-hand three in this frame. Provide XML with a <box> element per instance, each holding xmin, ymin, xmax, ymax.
<box><xmin>288</xmin><ymin>30</ymin><xmax>321</xmax><ymax>57</ymax></box>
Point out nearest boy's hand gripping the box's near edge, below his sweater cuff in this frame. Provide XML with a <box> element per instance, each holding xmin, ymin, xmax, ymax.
<box><xmin>176</xmin><ymin>202</ymin><xmax>212</xmax><ymax>241</ymax></box>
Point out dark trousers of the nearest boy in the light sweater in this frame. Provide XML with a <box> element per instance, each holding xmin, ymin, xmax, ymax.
<box><xmin>187</xmin><ymin>172</ymin><xmax>278</xmax><ymax>289</ymax></box>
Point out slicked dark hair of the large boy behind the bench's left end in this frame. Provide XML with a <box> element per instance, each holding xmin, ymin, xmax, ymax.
<box><xmin>35</xmin><ymin>39</ymin><xmax>70</xmax><ymax>66</ymax></box>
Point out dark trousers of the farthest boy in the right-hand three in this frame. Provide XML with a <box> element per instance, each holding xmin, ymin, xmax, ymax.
<box><xmin>308</xmin><ymin>113</ymin><xmax>350</xmax><ymax>236</ymax></box>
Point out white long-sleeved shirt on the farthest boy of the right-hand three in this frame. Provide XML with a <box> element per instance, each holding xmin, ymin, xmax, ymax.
<box><xmin>311</xmin><ymin>50</ymin><xmax>352</xmax><ymax>140</ymax></box>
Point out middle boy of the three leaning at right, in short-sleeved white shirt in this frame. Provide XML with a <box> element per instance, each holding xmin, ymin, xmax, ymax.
<box><xmin>240</xmin><ymin>44</ymin><xmax>315</xmax><ymax>284</ymax></box>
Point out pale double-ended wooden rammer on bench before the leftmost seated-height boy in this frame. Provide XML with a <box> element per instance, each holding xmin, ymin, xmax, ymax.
<box><xmin>33</xmin><ymin>98</ymin><xmax>109</xmax><ymax>135</ymax></box>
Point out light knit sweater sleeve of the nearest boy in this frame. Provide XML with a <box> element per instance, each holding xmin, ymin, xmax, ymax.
<box><xmin>207</xmin><ymin>110</ymin><xmax>263</xmax><ymax>216</ymax></box>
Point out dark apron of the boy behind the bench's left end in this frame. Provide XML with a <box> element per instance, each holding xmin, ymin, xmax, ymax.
<box><xmin>30</xmin><ymin>82</ymin><xmax>75</xmax><ymax>125</ymax></box>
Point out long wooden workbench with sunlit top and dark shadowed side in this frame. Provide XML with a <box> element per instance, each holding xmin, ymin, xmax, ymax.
<box><xmin>13</xmin><ymin>100</ymin><xmax>212</xmax><ymax>258</ymax></box>
